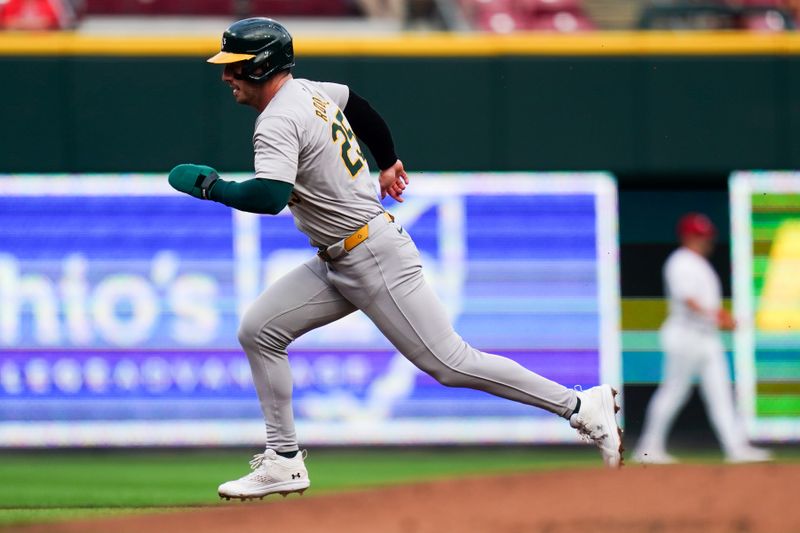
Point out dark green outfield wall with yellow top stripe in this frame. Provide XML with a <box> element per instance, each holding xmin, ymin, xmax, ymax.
<box><xmin>0</xmin><ymin>33</ymin><xmax>800</xmax><ymax>180</ymax></box>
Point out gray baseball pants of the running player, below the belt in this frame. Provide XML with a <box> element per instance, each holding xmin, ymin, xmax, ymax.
<box><xmin>234</xmin><ymin>215</ymin><xmax>577</xmax><ymax>452</ymax></box>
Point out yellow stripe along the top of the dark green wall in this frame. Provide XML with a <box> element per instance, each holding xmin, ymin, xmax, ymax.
<box><xmin>0</xmin><ymin>28</ymin><xmax>800</xmax><ymax>57</ymax></box>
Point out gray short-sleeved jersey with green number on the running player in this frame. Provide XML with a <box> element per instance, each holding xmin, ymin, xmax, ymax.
<box><xmin>253</xmin><ymin>79</ymin><xmax>383</xmax><ymax>246</ymax></box>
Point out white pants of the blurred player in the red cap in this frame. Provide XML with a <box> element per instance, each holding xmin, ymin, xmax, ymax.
<box><xmin>637</xmin><ymin>320</ymin><xmax>747</xmax><ymax>455</ymax></box>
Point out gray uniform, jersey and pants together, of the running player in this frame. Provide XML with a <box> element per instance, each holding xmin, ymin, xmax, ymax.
<box><xmin>234</xmin><ymin>79</ymin><xmax>577</xmax><ymax>452</ymax></box>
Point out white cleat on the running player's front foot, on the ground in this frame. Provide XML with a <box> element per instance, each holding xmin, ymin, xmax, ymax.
<box><xmin>218</xmin><ymin>449</ymin><xmax>311</xmax><ymax>500</ymax></box>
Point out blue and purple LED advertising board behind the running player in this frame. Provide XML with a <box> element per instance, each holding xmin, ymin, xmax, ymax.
<box><xmin>0</xmin><ymin>173</ymin><xmax>621</xmax><ymax>446</ymax></box>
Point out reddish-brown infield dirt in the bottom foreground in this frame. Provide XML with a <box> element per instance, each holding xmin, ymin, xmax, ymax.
<box><xmin>10</xmin><ymin>465</ymin><xmax>800</xmax><ymax>533</ymax></box>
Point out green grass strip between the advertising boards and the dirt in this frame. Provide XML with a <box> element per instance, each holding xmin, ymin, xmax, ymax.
<box><xmin>0</xmin><ymin>446</ymin><xmax>800</xmax><ymax>527</ymax></box>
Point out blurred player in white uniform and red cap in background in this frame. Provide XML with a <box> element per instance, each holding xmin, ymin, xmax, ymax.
<box><xmin>634</xmin><ymin>213</ymin><xmax>771</xmax><ymax>464</ymax></box>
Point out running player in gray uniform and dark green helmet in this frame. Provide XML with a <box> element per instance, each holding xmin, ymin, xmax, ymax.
<box><xmin>169</xmin><ymin>18</ymin><xmax>622</xmax><ymax>499</ymax></box>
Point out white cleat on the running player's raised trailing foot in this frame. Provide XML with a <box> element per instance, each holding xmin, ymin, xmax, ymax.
<box><xmin>569</xmin><ymin>385</ymin><xmax>625</xmax><ymax>468</ymax></box>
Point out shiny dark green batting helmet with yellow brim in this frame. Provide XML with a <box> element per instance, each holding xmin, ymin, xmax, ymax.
<box><xmin>208</xmin><ymin>17</ymin><xmax>294</xmax><ymax>82</ymax></box>
